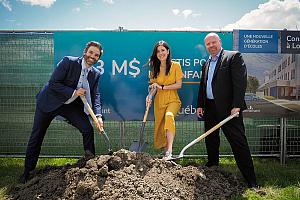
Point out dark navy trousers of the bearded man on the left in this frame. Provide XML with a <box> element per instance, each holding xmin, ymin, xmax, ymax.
<box><xmin>25</xmin><ymin>98</ymin><xmax>95</xmax><ymax>172</ymax></box>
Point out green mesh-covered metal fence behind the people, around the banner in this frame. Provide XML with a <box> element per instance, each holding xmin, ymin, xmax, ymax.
<box><xmin>0</xmin><ymin>32</ymin><xmax>300</xmax><ymax>163</ymax></box>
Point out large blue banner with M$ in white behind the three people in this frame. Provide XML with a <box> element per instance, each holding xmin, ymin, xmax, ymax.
<box><xmin>54</xmin><ymin>31</ymin><xmax>232</xmax><ymax>120</ymax></box>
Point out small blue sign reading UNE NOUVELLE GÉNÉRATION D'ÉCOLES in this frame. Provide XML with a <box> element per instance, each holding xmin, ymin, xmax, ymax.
<box><xmin>238</xmin><ymin>30</ymin><xmax>279</xmax><ymax>53</ymax></box>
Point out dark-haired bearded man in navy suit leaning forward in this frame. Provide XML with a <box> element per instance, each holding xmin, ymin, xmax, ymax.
<box><xmin>20</xmin><ymin>41</ymin><xmax>103</xmax><ymax>183</ymax></box>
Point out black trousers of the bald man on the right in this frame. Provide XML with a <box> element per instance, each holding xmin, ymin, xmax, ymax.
<box><xmin>205</xmin><ymin>99</ymin><xmax>256</xmax><ymax>186</ymax></box>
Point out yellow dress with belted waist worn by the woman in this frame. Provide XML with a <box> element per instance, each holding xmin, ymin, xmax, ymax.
<box><xmin>150</xmin><ymin>61</ymin><xmax>183</xmax><ymax>149</ymax></box>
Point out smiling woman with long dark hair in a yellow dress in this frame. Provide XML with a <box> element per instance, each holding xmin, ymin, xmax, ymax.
<box><xmin>146</xmin><ymin>41</ymin><xmax>183</xmax><ymax>160</ymax></box>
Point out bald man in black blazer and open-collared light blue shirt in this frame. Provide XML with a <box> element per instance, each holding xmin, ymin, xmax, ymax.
<box><xmin>197</xmin><ymin>33</ymin><xmax>257</xmax><ymax>188</ymax></box>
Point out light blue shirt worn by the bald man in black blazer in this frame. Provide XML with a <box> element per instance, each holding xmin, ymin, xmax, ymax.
<box><xmin>206</xmin><ymin>49</ymin><xmax>222</xmax><ymax>99</ymax></box>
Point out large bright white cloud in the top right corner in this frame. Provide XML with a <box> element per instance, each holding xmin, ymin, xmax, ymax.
<box><xmin>223</xmin><ymin>0</ymin><xmax>300</xmax><ymax>30</ymax></box>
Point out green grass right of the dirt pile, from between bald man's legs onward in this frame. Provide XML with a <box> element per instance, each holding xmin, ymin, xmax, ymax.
<box><xmin>227</xmin><ymin>158</ymin><xmax>300</xmax><ymax>200</ymax></box>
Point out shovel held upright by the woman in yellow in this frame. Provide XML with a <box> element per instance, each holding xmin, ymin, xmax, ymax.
<box><xmin>129</xmin><ymin>88</ymin><xmax>156</xmax><ymax>152</ymax></box>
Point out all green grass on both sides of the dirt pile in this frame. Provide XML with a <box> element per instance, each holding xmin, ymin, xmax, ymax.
<box><xmin>0</xmin><ymin>157</ymin><xmax>300</xmax><ymax>200</ymax></box>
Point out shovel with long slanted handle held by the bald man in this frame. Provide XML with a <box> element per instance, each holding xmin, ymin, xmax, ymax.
<box><xmin>168</xmin><ymin>112</ymin><xmax>239</xmax><ymax>160</ymax></box>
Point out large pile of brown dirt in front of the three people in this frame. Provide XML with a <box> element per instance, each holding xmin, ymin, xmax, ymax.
<box><xmin>10</xmin><ymin>149</ymin><xmax>245</xmax><ymax>200</ymax></box>
